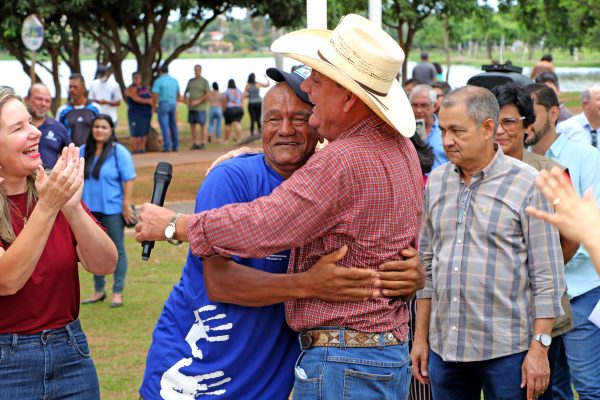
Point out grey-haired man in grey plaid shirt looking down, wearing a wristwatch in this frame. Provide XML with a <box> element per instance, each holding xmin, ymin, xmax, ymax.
<box><xmin>411</xmin><ymin>86</ymin><xmax>565</xmax><ymax>400</ymax></box>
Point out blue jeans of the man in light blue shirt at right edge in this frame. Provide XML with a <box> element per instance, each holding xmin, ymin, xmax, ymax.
<box><xmin>563</xmin><ymin>287</ymin><xmax>600</xmax><ymax>400</ymax></box>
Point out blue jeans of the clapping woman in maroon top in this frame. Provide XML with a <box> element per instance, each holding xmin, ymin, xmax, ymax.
<box><xmin>0</xmin><ymin>320</ymin><xmax>100</xmax><ymax>400</ymax></box>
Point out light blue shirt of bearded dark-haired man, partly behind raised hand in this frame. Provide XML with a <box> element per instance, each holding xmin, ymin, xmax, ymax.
<box><xmin>546</xmin><ymin>134</ymin><xmax>600</xmax><ymax>298</ymax></box>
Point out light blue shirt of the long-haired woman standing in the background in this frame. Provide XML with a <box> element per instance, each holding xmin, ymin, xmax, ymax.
<box><xmin>81</xmin><ymin>143</ymin><xmax>135</xmax><ymax>215</ymax></box>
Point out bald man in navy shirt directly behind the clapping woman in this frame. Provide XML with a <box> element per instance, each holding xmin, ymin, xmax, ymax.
<box><xmin>25</xmin><ymin>83</ymin><xmax>71</xmax><ymax>169</ymax></box>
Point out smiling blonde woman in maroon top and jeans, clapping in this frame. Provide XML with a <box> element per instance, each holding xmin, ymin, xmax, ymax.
<box><xmin>0</xmin><ymin>88</ymin><xmax>117</xmax><ymax>400</ymax></box>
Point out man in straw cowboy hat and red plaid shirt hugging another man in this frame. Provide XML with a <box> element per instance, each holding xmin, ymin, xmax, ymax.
<box><xmin>136</xmin><ymin>15</ymin><xmax>423</xmax><ymax>399</ymax></box>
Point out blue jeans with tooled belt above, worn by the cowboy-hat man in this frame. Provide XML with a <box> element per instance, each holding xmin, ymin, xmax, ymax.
<box><xmin>293</xmin><ymin>335</ymin><xmax>410</xmax><ymax>400</ymax></box>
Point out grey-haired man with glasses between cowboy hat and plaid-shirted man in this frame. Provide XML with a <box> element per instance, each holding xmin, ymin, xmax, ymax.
<box><xmin>409</xmin><ymin>85</ymin><xmax>448</xmax><ymax>169</ymax></box>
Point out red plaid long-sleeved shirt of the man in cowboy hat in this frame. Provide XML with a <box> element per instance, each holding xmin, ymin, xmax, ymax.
<box><xmin>188</xmin><ymin>116</ymin><xmax>423</xmax><ymax>340</ymax></box>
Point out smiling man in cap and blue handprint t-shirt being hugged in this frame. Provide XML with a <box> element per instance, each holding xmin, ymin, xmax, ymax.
<box><xmin>140</xmin><ymin>68</ymin><xmax>418</xmax><ymax>400</ymax></box>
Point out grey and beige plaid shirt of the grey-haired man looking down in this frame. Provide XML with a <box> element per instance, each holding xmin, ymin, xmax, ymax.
<box><xmin>418</xmin><ymin>146</ymin><xmax>565</xmax><ymax>361</ymax></box>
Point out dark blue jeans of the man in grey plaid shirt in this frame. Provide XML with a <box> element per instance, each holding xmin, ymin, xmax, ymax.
<box><xmin>429</xmin><ymin>350</ymin><xmax>527</xmax><ymax>400</ymax></box>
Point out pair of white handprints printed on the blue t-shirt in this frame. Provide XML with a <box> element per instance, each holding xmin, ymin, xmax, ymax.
<box><xmin>160</xmin><ymin>304</ymin><xmax>233</xmax><ymax>400</ymax></box>
